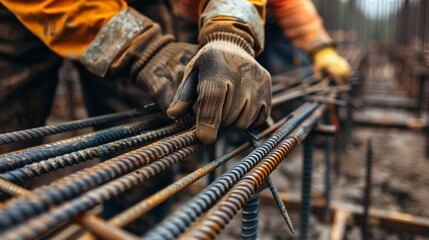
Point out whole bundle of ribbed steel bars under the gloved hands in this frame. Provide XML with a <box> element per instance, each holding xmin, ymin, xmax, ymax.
<box><xmin>0</xmin><ymin>60</ymin><xmax>358</xmax><ymax>239</ymax></box>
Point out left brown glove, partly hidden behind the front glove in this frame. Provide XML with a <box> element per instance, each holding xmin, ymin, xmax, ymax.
<box><xmin>120</xmin><ymin>24</ymin><xmax>198</xmax><ymax>110</ymax></box>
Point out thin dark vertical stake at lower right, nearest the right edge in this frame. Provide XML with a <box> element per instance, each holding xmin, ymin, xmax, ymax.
<box><xmin>362</xmin><ymin>139</ymin><xmax>372</xmax><ymax>239</ymax></box>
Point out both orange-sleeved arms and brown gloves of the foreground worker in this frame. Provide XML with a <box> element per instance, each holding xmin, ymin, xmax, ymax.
<box><xmin>1</xmin><ymin>0</ymin><xmax>271</xmax><ymax>147</ymax></box>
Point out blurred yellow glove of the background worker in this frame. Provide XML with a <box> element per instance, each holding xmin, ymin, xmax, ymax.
<box><xmin>313</xmin><ymin>47</ymin><xmax>350</xmax><ymax>85</ymax></box>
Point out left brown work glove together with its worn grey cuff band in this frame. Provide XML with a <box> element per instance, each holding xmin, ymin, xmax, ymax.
<box><xmin>80</xmin><ymin>7</ymin><xmax>198</xmax><ymax>110</ymax></box>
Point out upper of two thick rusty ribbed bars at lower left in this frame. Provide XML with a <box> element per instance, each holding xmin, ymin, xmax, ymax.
<box><xmin>0</xmin><ymin>130</ymin><xmax>198</xmax><ymax>229</ymax></box>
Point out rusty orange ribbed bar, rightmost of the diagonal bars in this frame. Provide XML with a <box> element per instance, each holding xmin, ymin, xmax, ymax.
<box><xmin>180</xmin><ymin>105</ymin><xmax>326</xmax><ymax>239</ymax></box>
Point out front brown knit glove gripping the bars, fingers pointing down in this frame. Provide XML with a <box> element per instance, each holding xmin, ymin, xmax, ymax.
<box><xmin>167</xmin><ymin>32</ymin><xmax>271</xmax><ymax>144</ymax></box>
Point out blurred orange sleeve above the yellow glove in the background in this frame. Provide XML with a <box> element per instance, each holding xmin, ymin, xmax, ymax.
<box><xmin>267</xmin><ymin>0</ymin><xmax>333</xmax><ymax>53</ymax></box>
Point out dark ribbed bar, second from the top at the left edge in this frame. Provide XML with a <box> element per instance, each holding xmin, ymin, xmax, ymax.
<box><xmin>0</xmin><ymin>116</ymin><xmax>169</xmax><ymax>173</ymax></box>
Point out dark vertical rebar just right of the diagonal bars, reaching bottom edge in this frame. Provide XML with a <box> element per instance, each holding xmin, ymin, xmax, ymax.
<box><xmin>300</xmin><ymin>133</ymin><xmax>314</xmax><ymax>240</ymax></box>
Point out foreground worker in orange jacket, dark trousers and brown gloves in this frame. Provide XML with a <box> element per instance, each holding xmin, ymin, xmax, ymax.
<box><xmin>0</xmin><ymin>0</ymin><xmax>271</xmax><ymax>233</ymax></box>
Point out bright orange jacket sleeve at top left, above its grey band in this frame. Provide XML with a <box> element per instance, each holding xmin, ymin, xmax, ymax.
<box><xmin>0</xmin><ymin>0</ymin><xmax>127</xmax><ymax>59</ymax></box>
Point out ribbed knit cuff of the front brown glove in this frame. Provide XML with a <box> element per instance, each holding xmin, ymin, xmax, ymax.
<box><xmin>200</xmin><ymin>32</ymin><xmax>255</xmax><ymax>57</ymax></box>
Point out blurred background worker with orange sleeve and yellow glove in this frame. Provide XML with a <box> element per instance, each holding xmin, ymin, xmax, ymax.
<box><xmin>175</xmin><ymin>0</ymin><xmax>350</xmax><ymax>84</ymax></box>
